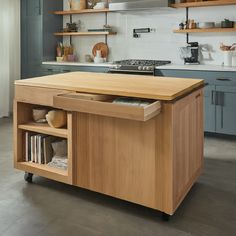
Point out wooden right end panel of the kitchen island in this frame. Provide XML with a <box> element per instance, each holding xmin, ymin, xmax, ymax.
<box><xmin>173</xmin><ymin>90</ymin><xmax>204</xmax><ymax>209</ymax></box>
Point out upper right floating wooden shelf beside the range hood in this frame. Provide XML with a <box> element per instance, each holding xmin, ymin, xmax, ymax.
<box><xmin>171</xmin><ymin>0</ymin><xmax>236</xmax><ymax>8</ymax></box>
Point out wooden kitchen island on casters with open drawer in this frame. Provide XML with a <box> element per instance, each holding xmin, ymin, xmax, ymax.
<box><xmin>14</xmin><ymin>72</ymin><xmax>204</xmax><ymax>219</ymax></box>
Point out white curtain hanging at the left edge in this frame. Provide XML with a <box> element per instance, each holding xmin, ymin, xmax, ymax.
<box><xmin>0</xmin><ymin>0</ymin><xmax>20</xmax><ymax>117</ymax></box>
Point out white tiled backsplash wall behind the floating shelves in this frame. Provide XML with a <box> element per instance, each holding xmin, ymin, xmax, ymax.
<box><xmin>64</xmin><ymin>0</ymin><xmax>236</xmax><ymax>65</ymax></box>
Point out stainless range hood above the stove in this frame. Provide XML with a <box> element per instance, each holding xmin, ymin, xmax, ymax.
<box><xmin>109</xmin><ymin>0</ymin><xmax>172</xmax><ymax>11</ymax></box>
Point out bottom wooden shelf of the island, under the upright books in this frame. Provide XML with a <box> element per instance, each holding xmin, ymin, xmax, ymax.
<box><xmin>15</xmin><ymin>161</ymin><xmax>70</xmax><ymax>184</ymax></box>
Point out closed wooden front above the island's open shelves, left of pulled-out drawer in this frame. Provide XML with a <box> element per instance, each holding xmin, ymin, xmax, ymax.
<box><xmin>15</xmin><ymin>85</ymin><xmax>66</xmax><ymax>106</ymax></box>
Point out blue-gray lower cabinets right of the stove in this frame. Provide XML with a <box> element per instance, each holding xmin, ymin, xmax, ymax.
<box><xmin>155</xmin><ymin>69</ymin><xmax>236</xmax><ymax>135</ymax></box>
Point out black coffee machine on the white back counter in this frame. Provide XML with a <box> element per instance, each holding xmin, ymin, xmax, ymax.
<box><xmin>181</xmin><ymin>42</ymin><xmax>200</xmax><ymax>65</ymax></box>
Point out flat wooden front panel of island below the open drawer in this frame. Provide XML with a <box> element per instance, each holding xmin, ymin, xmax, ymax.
<box><xmin>77</xmin><ymin>113</ymin><xmax>156</xmax><ymax>208</ymax></box>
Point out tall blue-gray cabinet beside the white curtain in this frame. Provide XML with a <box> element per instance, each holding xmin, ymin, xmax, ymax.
<box><xmin>21</xmin><ymin>0</ymin><xmax>63</xmax><ymax>79</ymax></box>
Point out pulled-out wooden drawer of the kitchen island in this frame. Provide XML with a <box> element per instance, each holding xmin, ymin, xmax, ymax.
<box><xmin>53</xmin><ymin>93</ymin><xmax>161</xmax><ymax>121</ymax></box>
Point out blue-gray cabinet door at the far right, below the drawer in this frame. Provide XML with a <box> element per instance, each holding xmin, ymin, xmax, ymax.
<box><xmin>216</xmin><ymin>86</ymin><xmax>236</xmax><ymax>135</ymax></box>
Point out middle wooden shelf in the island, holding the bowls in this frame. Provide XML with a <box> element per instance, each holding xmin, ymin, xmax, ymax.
<box><xmin>18</xmin><ymin>122</ymin><xmax>68</xmax><ymax>138</ymax></box>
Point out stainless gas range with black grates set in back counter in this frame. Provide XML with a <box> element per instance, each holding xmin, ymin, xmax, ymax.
<box><xmin>109</xmin><ymin>60</ymin><xmax>171</xmax><ymax>75</ymax></box>
